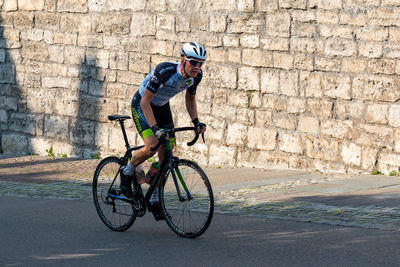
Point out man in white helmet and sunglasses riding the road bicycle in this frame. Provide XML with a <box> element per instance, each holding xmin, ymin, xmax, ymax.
<box><xmin>120</xmin><ymin>42</ymin><xmax>207</xmax><ymax>219</ymax></box>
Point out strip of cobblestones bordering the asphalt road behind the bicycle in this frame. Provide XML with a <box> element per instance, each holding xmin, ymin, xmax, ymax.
<box><xmin>0</xmin><ymin>180</ymin><xmax>400</xmax><ymax>230</ymax></box>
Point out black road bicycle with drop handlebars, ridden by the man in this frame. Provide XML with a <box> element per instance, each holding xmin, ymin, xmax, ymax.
<box><xmin>92</xmin><ymin>115</ymin><xmax>214</xmax><ymax>238</ymax></box>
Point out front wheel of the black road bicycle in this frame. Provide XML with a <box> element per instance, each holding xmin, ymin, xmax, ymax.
<box><xmin>159</xmin><ymin>159</ymin><xmax>214</xmax><ymax>238</ymax></box>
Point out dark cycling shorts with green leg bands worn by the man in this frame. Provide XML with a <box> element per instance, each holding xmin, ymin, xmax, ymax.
<box><xmin>131</xmin><ymin>91</ymin><xmax>175</xmax><ymax>145</ymax></box>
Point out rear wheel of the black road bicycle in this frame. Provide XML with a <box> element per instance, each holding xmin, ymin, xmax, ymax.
<box><xmin>92</xmin><ymin>157</ymin><xmax>136</xmax><ymax>232</ymax></box>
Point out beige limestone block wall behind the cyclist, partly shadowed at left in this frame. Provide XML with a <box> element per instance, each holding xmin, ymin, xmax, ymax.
<box><xmin>0</xmin><ymin>0</ymin><xmax>400</xmax><ymax>173</ymax></box>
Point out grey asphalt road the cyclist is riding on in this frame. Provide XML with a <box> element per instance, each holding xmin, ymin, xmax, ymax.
<box><xmin>0</xmin><ymin>197</ymin><xmax>400</xmax><ymax>266</ymax></box>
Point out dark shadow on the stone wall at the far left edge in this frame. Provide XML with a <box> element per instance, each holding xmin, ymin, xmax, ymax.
<box><xmin>0</xmin><ymin>13</ymin><xmax>33</xmax><ymax>155</ymax></box>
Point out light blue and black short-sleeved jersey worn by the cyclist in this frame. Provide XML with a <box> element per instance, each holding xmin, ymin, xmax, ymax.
<box><xmin>139</xmin><ymin>62</ymin><xmax>203</xmax><ymax>106</ymax></box>
